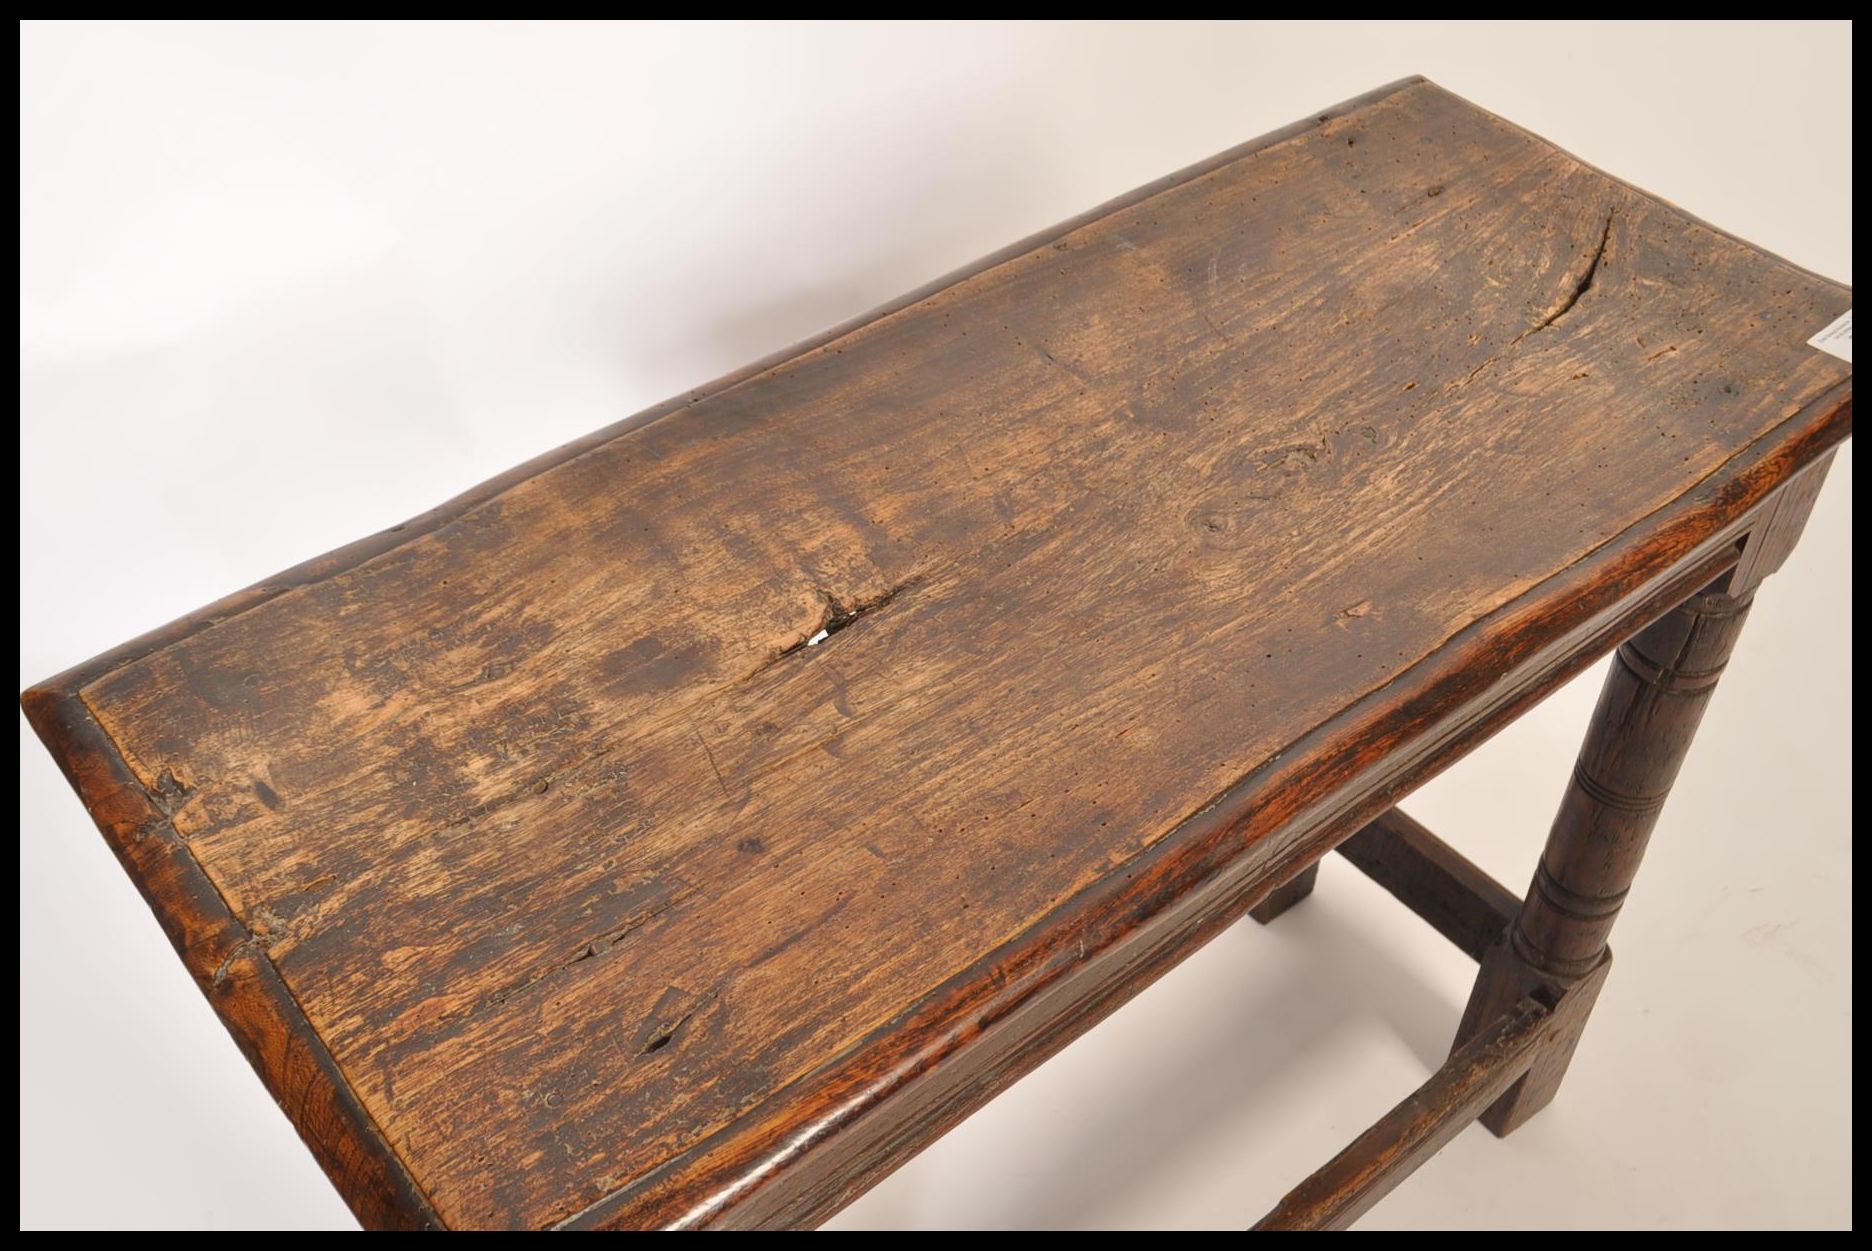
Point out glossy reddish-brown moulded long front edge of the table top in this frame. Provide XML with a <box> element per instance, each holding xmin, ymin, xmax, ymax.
<box><xmin>560</xmin><ymin>375</ymin><xmax>1853</xmax><ymax>1229</ymax></box>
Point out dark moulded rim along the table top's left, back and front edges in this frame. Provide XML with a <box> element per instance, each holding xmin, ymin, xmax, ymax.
<box><xmin>22</xmin><ymin>79</ymin><xmax>1851</xmax><ymax>1227</ymax></box>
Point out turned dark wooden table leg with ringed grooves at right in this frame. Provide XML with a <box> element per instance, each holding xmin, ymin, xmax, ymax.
<box><xmin>1456</xmin><ymin>463</ymin><xmax>1827</xmax><ymax>1135</ymax></box>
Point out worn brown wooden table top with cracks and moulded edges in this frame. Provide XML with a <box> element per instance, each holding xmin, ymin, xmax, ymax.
<box><xmin>24</xmin><ymin>81</ymin><xmax>1851</xmax><ymax>1227</ymax></box>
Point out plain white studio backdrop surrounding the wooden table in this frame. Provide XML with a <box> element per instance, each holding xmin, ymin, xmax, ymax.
<box><xmin>21</xmin><ymin>22</ymin><xmax>1851</xmax><ymax>1230</ymax></box>
